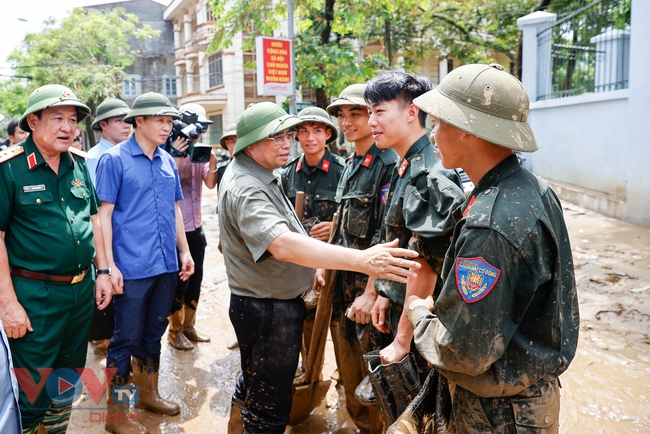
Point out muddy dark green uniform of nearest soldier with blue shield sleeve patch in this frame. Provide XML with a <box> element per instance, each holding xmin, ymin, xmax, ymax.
<box><xmin>409</xmin><ymin>156</ymin><xmax>579</xmax><ymax>433</ymax></box>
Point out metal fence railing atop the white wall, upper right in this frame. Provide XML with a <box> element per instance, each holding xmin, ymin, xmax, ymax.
<box><xmin>537</xmin><ymin>0</ymin><xmax>631</xmax><ymax>100</ymax></box>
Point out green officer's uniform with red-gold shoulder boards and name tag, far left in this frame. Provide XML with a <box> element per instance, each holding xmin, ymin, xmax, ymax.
<box><xmin>0</xmin><ymin>135</ymin><xmax>99</xmax><ymax>427</ymax></box>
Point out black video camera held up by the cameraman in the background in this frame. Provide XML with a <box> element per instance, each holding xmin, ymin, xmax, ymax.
<box><xmin>163</xmin><ymin>110</ymin><xmax>212</xmax><ymax>163</ymax></box>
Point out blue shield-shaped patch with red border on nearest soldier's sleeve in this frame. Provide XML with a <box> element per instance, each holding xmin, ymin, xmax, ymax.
<box><xmin>456</xmin><ymin>257</ymin><xmax>501</xmax><ymax>303</ymax></box>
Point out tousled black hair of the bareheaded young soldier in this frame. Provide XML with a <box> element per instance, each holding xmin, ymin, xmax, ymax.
<box><xmin>363</xmin><ymin>71</ymin><xmax>433</xmax><ymax>127</ymax></box>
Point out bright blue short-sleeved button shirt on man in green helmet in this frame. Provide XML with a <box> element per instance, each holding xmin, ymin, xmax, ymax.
<box><xmin>96</xmin><ymin>135</ymin><xmax>183</xmax><ymax>280</ymax></box>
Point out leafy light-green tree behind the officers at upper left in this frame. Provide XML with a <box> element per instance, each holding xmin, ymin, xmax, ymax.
<box><xmin>0</xmin><ymin>8</ymin><xmax>160</xmax><ymax>146</ymax></box>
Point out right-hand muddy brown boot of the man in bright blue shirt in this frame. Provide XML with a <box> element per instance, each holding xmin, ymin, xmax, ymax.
<box><xmin>131</xmin><ymin>356</ymin><xmax>181</xmax><ymax>416</ymax></box>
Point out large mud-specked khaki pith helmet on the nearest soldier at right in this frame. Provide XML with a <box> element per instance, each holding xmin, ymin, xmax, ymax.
<box><xmin>413</xmin><ymin>64</ymin><xmax>539</xmax><ymax>152</ymax></box>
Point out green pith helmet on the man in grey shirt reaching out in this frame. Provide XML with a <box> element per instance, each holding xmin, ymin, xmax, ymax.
<box><xmin>233</xmin><ymin>101</ymin><xmax>302</xmax><ymax>155</ymax></box>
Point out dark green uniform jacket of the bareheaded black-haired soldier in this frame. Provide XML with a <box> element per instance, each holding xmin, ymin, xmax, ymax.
<box><xmin>375</xmin><ymin>135</ymin><xmax>465</xmax><ymax>333</ymax></box>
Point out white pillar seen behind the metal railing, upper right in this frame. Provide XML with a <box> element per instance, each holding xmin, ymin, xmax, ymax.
<box><xmin>589</xmin><ymin>28</ymin><xmax>630</xmax><ymax>92</ymax></box>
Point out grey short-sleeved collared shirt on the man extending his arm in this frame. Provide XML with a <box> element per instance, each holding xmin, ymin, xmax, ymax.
<box><xmin>219</xmin><ymin>153</ymin><xmax>314</xmax><ymax>300</ymax></box>
